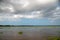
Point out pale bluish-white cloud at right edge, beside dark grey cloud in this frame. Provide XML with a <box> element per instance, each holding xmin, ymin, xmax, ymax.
<box><xmin>48</xmin><ymin>6</ymin><xmax>60</xmax><ymax>22</ymax></box>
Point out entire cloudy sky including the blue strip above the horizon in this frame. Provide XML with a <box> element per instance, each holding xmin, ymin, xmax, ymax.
<box><xmin>0</xmin><ymin>0</ymin><xmax>60</xmax><ymax>25</ymax></box>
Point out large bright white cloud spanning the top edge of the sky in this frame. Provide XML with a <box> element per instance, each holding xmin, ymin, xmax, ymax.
<box><xmin>1</xmin><ymin>0</ymin><xmax>57</xmax><ymax>10</ymax></box>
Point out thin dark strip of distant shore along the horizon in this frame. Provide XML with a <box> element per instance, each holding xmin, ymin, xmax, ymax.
<box><xmin>0</xmin><ymin>25</ymin><xmax>60</xmax><ymax>27</ymax></box>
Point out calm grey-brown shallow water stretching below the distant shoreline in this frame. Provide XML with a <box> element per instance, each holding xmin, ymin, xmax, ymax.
<box><xmin>0</xmin><ymin>27</ymin><xmax>60</xmax><ymax>40</ymax></box>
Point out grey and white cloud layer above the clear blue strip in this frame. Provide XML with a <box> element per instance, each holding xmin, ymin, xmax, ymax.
<box><xmin>0</xmin><ymin>0</ymin><xmax>60</xmax><ymax>22</ymax></box>
